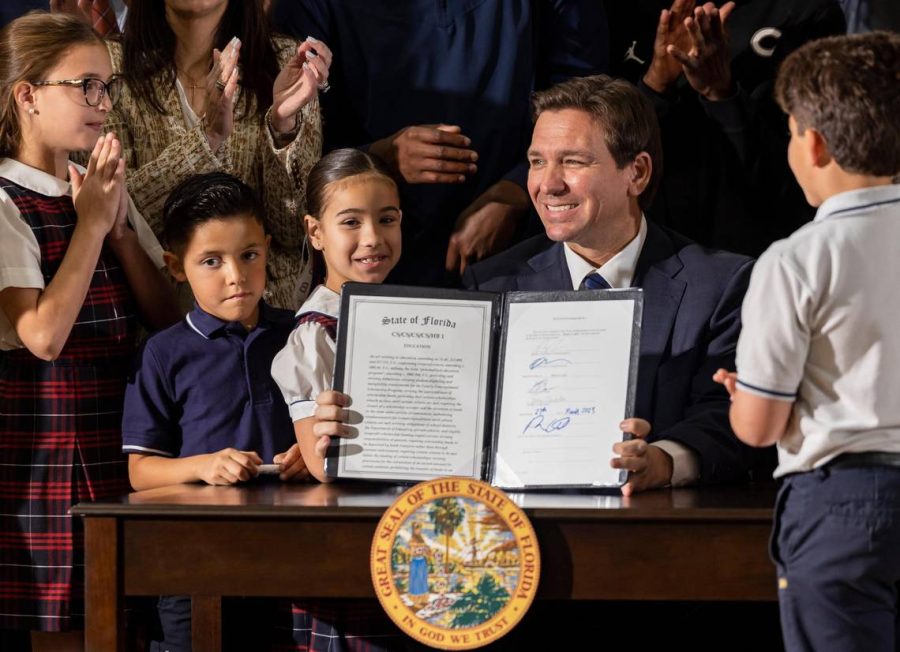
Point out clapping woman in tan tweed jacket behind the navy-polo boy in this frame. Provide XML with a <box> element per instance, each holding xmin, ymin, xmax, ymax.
<box><xmin>106</xmin><ymin>0</ymin><xmax>331</xmax><ymax>309</ymax></box>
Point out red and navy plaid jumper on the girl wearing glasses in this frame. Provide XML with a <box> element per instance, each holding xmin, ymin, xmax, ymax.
<box><xmin>0</xmin><ymin>179</ymin><xmax>137</xmax><ymax>631</ymax></box>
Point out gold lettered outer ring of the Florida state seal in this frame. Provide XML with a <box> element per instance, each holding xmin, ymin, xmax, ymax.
<box><xmin>369</xmin><ymin>477</ymin><xmax>541</xmax><ymax>650</ymax></box>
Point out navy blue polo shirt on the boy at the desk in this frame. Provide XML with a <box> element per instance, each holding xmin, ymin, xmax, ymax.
<box><xmin>122</xmin><ymin>302</ymin><xmax>296</xmax><ymax>464</ymax></box>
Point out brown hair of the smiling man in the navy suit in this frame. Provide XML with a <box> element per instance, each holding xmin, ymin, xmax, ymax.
<box><xmin>531</xmin><ymin>75</ymin><xmax>662</xmax><ymax>209</ymax></box>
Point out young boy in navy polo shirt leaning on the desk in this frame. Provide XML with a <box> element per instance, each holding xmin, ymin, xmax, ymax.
<box><xmin>122</xmin><ymin>172</ymin><xmax>308</xmax><ymax>650</ymax></box>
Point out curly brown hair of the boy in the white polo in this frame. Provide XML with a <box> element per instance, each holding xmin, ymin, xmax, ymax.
<box><xmin>775</xmin><ymin>32</ymin><xmax>900</xmax><ymax>176</ymax></box>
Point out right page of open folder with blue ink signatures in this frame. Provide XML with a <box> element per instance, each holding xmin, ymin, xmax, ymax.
<box><xmin>492</xmin><ymin>289</ymin><xmax>642</xmax><ymax>488</ymax></box>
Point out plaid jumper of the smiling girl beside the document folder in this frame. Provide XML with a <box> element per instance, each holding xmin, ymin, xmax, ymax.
<box><xmin>276</xmin><ymin>312</ymin><xmax>400</xmax><ymax>652</ymax></box>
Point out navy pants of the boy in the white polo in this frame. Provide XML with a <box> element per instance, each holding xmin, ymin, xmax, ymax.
<box><xmin>771</xmin><ymin>464</ymin><xmax>900</xmax><ymax>652</ymax></box>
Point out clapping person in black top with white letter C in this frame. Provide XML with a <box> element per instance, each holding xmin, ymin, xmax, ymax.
<box><xmin>607</xmin><ymin>0</ymin><xmax>845</xmax><ymax>256</ymax></box>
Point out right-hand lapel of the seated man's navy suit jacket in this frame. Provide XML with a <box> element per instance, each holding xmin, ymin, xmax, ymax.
<box><xmin>634</xmin><ymin>222</ymin><xmax>685</xmax><ymax>415</ymax></box>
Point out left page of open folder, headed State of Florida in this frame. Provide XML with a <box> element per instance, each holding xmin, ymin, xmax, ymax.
<box><xmin>326</xmin><ymin>284</ymin><xmax>499</xmax><ymax>481</ymax></box>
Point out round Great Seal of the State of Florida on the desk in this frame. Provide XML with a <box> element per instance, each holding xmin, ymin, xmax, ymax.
<box><xmin>370</xmin><ymin>478</ymin><xmax>540</xmax><ymax>650</ymax></box>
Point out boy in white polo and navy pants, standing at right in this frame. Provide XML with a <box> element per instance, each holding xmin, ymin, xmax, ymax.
<box><xmin>716</xmin><ymin>32</ymin><xmax>900</xmax><ymax>652</ymax></box>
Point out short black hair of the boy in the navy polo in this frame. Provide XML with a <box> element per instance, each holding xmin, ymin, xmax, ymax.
<box><xmin>162</xmin><ymin>172</ymin><xmax>266</xmax><ymax>251</ymax></box>
